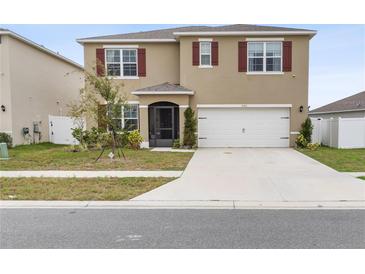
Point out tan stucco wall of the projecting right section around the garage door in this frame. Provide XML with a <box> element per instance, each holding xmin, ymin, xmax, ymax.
<box><xmin>180</xmin><ymin>36</ymin><xmax>309</xmax><ymax>148</ymax></box>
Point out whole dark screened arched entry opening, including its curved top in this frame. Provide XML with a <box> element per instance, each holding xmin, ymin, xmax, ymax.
<box><xmin>148</xmin><ymin>102</ymin><xmax>180</xmax><ymax>147</ymax></box>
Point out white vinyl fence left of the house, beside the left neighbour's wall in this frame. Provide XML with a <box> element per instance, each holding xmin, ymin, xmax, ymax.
<box><xmin>48</xmin><ymin>115</ymin><xmax>86</xmax><ymax>145</ymax></box>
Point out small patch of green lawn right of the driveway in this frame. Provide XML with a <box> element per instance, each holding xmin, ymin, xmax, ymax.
<box><xmin>297</xmin><ymin>147</ymin><xmax>365</xmax><ymax>172</ymax></box>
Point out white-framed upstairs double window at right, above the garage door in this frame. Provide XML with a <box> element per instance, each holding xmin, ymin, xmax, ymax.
<box><xmin>248</xmin><ymin>42</ymin><xmax>282</xmax><ymax>72</ymax></box>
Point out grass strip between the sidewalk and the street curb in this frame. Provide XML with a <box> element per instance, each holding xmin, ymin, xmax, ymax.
<box><xmin>0</xmin><ymin>178</ymin><xmax>173</xmax><ymax>201</ymax></box>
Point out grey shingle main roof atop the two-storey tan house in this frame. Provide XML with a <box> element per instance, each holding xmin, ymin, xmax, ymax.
<box><xmin>78</xmin><ymin>24</ymin><xmax>311</xmax><ymax>40</ymax></box>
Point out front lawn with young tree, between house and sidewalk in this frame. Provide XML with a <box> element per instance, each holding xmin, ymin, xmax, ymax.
<box><xmin>0</xmin><ymin>143</ymin><xmax>193</xmax><ymax>170</ymax></box>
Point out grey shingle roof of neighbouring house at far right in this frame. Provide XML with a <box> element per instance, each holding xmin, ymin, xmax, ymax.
<box><xmin>309</xmin><ymin>91</ymin><xmax>365</xmax><ymax>113</ymax></box>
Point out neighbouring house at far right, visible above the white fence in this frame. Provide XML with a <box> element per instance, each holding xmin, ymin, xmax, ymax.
<box><xmin>309</xmin><ymin>91</ymin><xmax>365</xmax><ymax>119</ymax></box>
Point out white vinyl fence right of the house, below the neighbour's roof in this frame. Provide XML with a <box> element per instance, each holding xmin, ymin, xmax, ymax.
<box><xmin>311</xmin><ymin>118</ymin><xmax>365</xmax><ymax>148</ymax></box>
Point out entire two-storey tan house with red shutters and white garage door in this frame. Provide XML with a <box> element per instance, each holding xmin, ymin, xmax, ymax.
<box><xmin>77</xmin><ymin>25</ymin><xmax>316</xmax><ymax>147</ymax></box>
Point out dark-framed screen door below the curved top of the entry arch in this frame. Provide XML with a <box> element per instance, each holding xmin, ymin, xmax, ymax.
<box><xmin>150</xmin><ymin>106</ymin><xmax>177</xmax><ymax>147</ymax></box>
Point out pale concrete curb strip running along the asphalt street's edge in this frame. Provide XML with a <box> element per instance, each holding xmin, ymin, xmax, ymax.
<box><xmin>0</xmin><ymin>200</ymin><xmax>365</xmax><ymax>209</ymax></box>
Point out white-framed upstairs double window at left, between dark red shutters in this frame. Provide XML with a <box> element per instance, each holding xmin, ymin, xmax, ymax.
<box><xmin>106</xmin><ymin>49</ymin><xmax>137</xmax><ymax>77</ymax></box>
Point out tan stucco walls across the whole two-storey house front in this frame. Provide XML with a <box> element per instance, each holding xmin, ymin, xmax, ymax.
<box><xmin>84</xmin><ymin>36</ymin><xmax>310</xmax><ymax>145</ymax></box>
